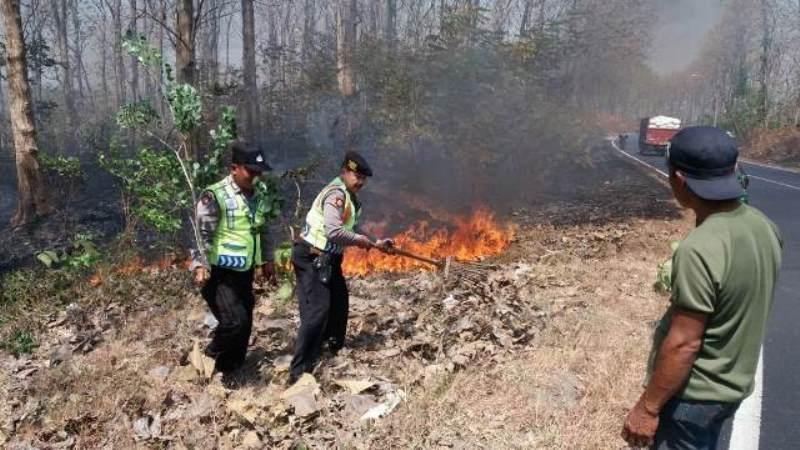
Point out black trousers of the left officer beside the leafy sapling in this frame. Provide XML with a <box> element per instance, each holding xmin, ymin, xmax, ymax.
<box><xmin>201</xmin><ymin>266</ymin><xmax>255</xmax><ymax>372</ymax></box>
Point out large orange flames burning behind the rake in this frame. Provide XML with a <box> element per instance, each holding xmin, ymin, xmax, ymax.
<box><xmin>342</xmin><ymin>208</ymin><xmax>514</xmax><ymax>275</ymax></box>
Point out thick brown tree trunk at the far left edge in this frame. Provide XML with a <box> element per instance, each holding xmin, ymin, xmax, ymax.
<box><xmin>0</xmin><ymin>0</ymin><xmax>50</xmax><ymax>227</ymax></box>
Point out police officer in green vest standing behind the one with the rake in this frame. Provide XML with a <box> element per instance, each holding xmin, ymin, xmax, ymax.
<box><xmin>192</xmin><ymin>142</ymin><xmax>275</xmax><ymax>373</ymax></box>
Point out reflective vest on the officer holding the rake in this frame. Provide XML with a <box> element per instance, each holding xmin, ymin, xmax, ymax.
<box><xmin>300</xmin><ymin>177</ymin><xmax>361</xmax><ymax>254</ymax></box>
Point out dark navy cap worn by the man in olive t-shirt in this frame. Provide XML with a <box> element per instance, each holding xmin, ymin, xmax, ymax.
<box><xmin>667</xmin><ymin>127</ymin><xmax>742</xmax><ymax>200</ymax></box>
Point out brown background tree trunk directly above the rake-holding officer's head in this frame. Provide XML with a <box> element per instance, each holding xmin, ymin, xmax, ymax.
<box><xmin>336</xmin><ymin>0</ymin><xmax>358</xmax><ymax>98</ymax></box>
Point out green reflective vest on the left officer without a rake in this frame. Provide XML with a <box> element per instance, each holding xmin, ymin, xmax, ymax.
<box><xmin>208</xmin><ymin>177</ymin><xmax>266</xmax><ymax>272</ymax></box>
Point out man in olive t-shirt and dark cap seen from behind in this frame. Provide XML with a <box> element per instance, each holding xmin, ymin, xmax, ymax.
<box><xmin>622</xmin><ymin>127</ymin><xmax>782</xmax><ymax>449</ymax></box>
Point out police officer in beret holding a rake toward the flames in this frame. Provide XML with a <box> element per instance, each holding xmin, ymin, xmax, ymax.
<box><xmin>289</xmin><ymin>152</ymin><xmax>393</xmax><ymax>384</ymax></box>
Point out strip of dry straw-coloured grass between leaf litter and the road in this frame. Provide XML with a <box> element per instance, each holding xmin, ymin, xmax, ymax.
<box><xmin>360</xmin><ymin>216</ymin><xmax>688</xmax><ymax>449</ymax></box>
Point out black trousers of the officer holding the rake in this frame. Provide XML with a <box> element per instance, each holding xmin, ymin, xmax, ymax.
<box><xmin>290</xmin><ymin>243</ymin><xmax>350</xmax><ymax>377</ymax></box>
